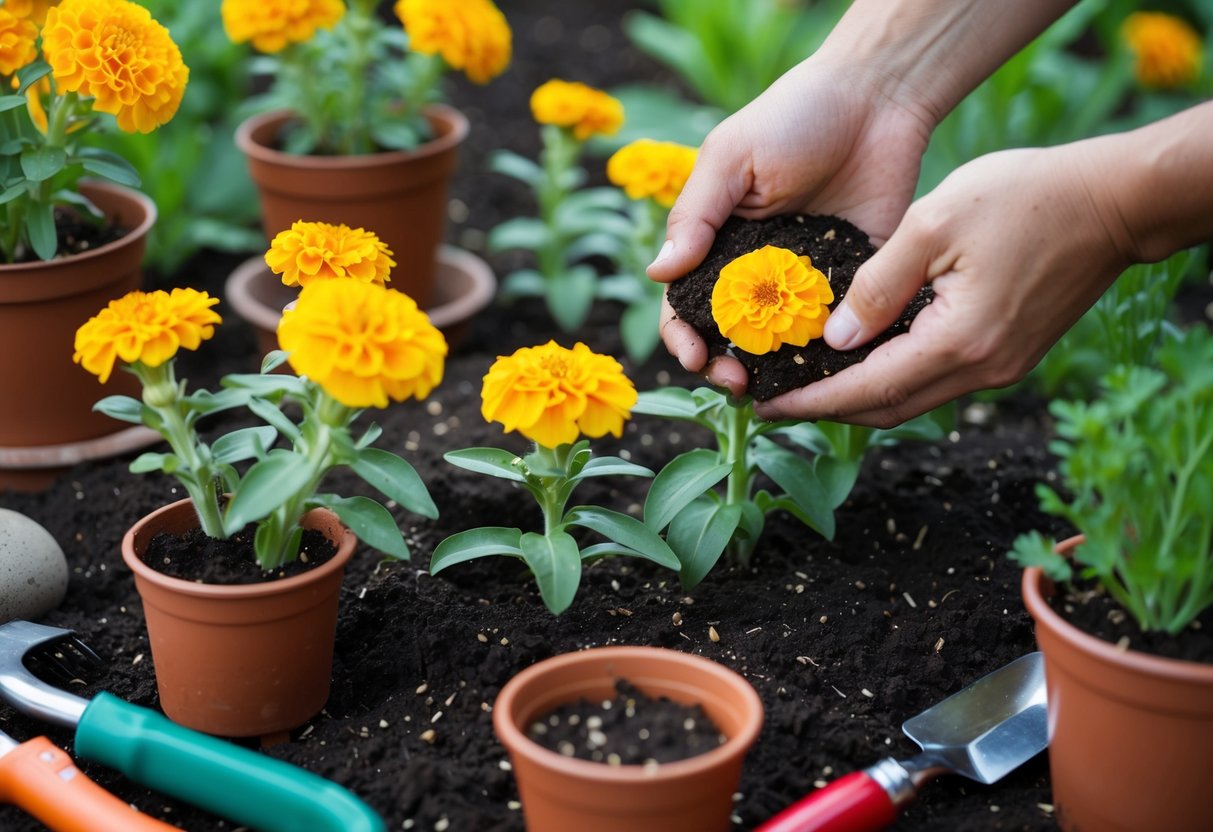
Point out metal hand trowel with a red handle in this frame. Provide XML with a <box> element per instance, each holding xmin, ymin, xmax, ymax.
<box><xmin>758</xmin><ymin>653</ymin><xmax>1049</xmax><ymax>832</ymax></box>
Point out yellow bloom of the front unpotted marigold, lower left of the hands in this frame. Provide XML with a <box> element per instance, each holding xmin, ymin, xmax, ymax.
<box><xmin>480</xmin><ymin>341</ymin><xmax>637</xmax><ymax>448</ymax></box>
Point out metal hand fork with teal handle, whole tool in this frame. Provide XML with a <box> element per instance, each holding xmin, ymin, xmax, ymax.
<box><xmin>0</xmin><ymin>621</ymin><xmax>383</xmax><ymax>832</ymax></box>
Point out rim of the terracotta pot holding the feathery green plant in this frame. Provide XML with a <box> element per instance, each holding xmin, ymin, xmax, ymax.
<box><xmin>1020</xmin><ymin>535</ymin><xmax>1213</xmax><ymax>684</ymax></box>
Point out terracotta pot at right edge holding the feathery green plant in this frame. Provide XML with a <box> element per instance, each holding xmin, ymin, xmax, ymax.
<box><xmin>1023</xmin><ymin>536</ymin><xmax>1213</xmax><ymax>832</ymax></box>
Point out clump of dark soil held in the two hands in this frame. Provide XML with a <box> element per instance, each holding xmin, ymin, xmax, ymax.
<box><xmin>666</xmin><ymin>213</ymin><xmax>934</xmax><ymax>401</ymax></box>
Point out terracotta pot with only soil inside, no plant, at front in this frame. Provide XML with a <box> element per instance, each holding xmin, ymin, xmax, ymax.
<box><xmin>492</xmin><ymin>646</ymin><xmax>763</xmax><ymax>832</ymax></box>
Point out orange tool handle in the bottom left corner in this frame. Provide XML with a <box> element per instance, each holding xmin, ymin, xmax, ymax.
<box><xmin>0</xmin><ymin>736</ymin><xmax>177</xmax><ymax>832</ymax></box>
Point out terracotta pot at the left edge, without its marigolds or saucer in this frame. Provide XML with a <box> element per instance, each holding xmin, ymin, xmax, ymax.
<box><xmin>0</xmin><ymin>182</ymin><xmax>156</xmax><ymax>455</ymax></box>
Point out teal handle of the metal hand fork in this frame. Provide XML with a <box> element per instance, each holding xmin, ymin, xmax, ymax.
<box><xmin>75</xmin><ymin>693</ymin><xmax>383</xmax><ymax>832</ymax></box>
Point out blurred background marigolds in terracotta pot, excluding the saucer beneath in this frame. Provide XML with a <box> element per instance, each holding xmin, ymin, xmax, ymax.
<box><xmin>221</xmin><ymin>0</ymin><xmax>511</xmax><ymax>308</ymax></box>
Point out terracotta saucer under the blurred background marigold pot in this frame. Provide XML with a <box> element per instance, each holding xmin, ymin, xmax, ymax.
<box><xmin>223</xmin><ymin>245</ymin><xmax>497</xmax><ymax>355</ymax></box>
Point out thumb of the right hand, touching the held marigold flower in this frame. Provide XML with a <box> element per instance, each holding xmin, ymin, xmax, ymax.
<box><xmin>822</xmin><ymin>226</ymin><xmax>930</xmax><ymax>349</ymax></box>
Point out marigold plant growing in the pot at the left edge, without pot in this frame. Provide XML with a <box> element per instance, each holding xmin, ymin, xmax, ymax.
<box><xmin>0</xmin><ymin>0</ymin><xmax>189</xmax><ymax>262</ymax></box>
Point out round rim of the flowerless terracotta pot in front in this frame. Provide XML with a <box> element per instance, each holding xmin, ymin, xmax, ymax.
<box><xmin>492</xmin><ymin>645</ymin><xmax>763</xmax><ymax>783</ymax></box>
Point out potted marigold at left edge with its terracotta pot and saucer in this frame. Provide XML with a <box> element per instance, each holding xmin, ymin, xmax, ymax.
<box><xmin>0</xmin><ymin>0</ymin><xmax>189</xmax><ymax>475</ymax></box>
